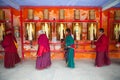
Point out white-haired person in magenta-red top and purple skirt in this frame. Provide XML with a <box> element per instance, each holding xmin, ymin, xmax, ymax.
<box><xmin>36</xmin><ymin>30</ymin><xmax>51</xmax><ymax>69</ymax></box>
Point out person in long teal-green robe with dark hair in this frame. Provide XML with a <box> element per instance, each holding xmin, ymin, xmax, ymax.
<box><xmin>65</xmin><ymin>28</ymin><xmax>75</xmax><ymax>68</ymax></box>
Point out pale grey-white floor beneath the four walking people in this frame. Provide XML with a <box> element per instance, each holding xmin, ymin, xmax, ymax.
<box><xmin>0</xmin><ymin>59</ymin><xmax>120</xmax><ymax>80</ymax></box>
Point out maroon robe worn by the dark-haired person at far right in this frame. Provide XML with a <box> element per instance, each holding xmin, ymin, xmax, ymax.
<box><xmin>95</xmin><ymin>34</ymin><xmax>111</xmax><ymax>67</ymax></box>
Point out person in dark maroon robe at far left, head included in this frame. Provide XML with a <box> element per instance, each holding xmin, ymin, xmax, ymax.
<box><xmin>2</xmin><ymin>29</ymin><xmax>20</xmax><ymax>68</ymax></box>
